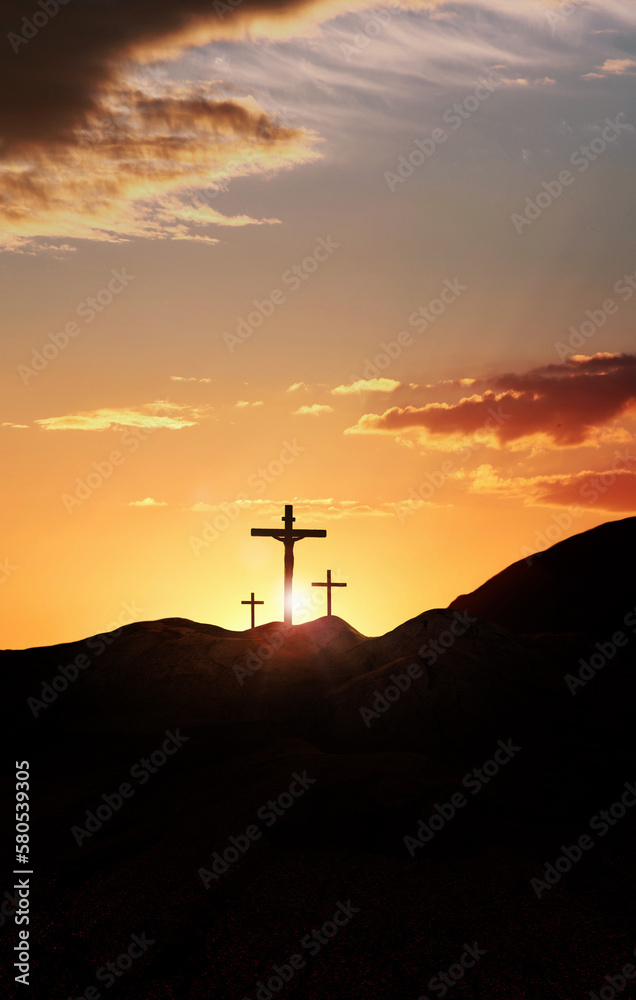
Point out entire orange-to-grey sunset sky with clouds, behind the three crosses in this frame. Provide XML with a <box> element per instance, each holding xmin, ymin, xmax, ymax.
<box><xmin>0</xmin><ymin>0</ymin><xmax>636</xmax><ymax>648</ymax></box>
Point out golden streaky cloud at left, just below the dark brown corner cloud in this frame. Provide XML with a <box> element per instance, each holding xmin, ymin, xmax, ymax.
<box><xmin>0</xmin><ymin>86</ymin><xmax>318</xmax><ymax>248</ymax></box>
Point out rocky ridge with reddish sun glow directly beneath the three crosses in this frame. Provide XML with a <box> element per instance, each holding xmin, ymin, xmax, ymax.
<box><xmin>0</xmin><ymin>610</ymin><xmax>578</xmax><ymax>753</ymax></box>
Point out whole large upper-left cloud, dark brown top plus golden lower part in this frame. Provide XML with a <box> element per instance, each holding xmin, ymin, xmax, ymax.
<box><xmin>0</xmin><ymin>0</ymin><xmax>360</xmax><ymax>249</ymax></box>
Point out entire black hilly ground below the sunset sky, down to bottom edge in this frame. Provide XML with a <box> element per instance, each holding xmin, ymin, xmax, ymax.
<box><xmin>0</xmin><ymin>519</ymin><xmax>636</xmax><ymax>1000</ymax></box>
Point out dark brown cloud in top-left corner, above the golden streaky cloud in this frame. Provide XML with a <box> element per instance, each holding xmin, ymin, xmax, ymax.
<box><xmin>0</xmin><ymin>0</ymin><xmax>398</xmax><ymax>155</ymax></box>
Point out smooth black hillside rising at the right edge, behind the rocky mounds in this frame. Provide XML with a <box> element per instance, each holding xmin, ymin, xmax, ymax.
<box><xmin>449</xmin><ymin>517</ymin><xmax>636</xmax><ymax>637</ymax></box>
